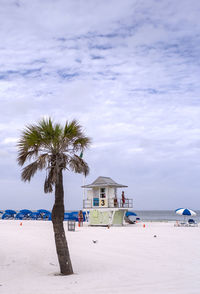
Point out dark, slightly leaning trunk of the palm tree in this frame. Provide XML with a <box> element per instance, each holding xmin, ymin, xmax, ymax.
<box><xmin>52</xmin><ymin>170</ymin><xmax>73</xmax><ymax>275</ymax></box>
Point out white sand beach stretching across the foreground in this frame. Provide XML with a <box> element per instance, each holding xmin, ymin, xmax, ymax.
<box><xmin>0</xmin><ymin>220</ymin><xmax>200</xmax><ymax>294</ymax></box>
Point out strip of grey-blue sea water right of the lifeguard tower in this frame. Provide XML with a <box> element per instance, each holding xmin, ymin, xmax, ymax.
<box><xmin>134</xmin><ymin>210</ymin><xmax>200</xmax><ymax>222</ymax></box>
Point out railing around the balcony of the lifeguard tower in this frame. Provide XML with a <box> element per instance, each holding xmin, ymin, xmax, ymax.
<box><xmin>83</xmin><ymin>198</ymin><xmax>133</xmax><ymax>208</ymax></box>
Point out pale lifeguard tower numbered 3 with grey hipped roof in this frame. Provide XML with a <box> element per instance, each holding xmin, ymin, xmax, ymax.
<box><xmin>82</xmin><ymin>177</ymin><xmax>133</xmax><ymax>226</ymax></box>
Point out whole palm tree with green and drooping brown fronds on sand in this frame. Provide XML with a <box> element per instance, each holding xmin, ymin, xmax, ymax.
<box><xmin>17</xmin><ymin>118</ymin><xmax>90</xmax><ymax>275</ymax></box>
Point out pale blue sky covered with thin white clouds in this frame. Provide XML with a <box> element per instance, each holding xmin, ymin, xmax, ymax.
<box><xmin>0</xmin><ymin>0</ymin><xmax>200</xmax><ymax>210</ymax></box>
